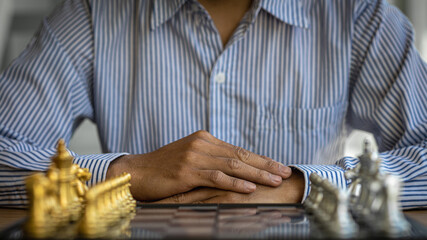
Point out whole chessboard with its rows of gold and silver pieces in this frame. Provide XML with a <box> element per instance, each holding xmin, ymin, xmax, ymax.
<box><xmin>0</xmin><ymin>140</ymin><xmax>427</xmax><ymax>239</ymax></box>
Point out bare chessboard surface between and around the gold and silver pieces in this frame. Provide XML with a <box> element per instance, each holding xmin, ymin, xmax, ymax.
<box><xmin>0</xmin><ymin>204</ymin><xmax>427</xmax><ymax>239</ymax></box>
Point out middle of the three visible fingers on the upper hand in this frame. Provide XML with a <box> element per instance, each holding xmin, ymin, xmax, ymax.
<box><xmin>198</xmin><ymin>156</ymin><xmax>282</xmax><ymax>187</ymax></box>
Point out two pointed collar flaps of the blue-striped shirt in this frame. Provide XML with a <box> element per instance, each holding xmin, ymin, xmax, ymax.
<box><xmin>150</xmin><ymin>0</ymin><xmax>309</xmax><ymax>29</ymax></box>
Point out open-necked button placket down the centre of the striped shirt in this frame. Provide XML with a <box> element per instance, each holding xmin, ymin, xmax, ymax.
<box><xmin>190</xmin><ymin>1</ymin><xmax>259</xmax><ymax>141</ymax></box>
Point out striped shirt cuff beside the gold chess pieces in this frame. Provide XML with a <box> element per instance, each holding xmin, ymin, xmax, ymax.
<box><xmin>74</xmin><ymin>153</ymin><xmax>128</xmax><ymax>186</ymax></box>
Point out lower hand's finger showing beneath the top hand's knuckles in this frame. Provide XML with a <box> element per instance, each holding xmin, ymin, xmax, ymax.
<box><xmin>151</xmin><ymin>188</ymin><xmax>218</xmax><ymax>204</ymax></box>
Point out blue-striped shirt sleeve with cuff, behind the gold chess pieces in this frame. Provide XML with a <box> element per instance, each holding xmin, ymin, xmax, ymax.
<box><xmin>0</xmin><ymin>1</ymin><xmax>125</xmax><ymax>207</ymax></box>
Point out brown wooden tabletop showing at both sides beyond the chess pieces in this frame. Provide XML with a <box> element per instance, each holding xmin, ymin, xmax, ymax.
<box><xmin>0</xmin><ymin>208</ymin><xmax>427</xmax><ymax>231</ymax></box>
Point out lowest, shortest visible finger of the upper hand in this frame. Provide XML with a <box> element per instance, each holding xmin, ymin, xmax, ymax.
<box><xmin>199</xmin><ymin>170</ymin><xmax>256</xmax><ymax>193</ymax></box>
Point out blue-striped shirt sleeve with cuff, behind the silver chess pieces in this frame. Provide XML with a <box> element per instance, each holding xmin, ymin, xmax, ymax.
<box><xmin>295</xmin><ymin>1</ymin><xmax>427</xmax><ymax>209</ymax></box>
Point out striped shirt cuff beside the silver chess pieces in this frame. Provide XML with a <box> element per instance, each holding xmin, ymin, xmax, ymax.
<box><xmin>290</xmin><ymin>165</ymin><xmax>347</xmax><ymax>202</ymax></box>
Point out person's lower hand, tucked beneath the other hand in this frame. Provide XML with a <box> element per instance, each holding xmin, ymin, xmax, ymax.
<box><xmin>153</xmin><ymin>170</ymin><xmax>304</xmax><ymax>204</ymax></box>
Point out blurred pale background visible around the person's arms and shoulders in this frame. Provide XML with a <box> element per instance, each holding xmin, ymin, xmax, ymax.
<box><xmin>0</xmin><ymin>0</ymin><xmax>427</xmax><ymax>156</ymax></box>
